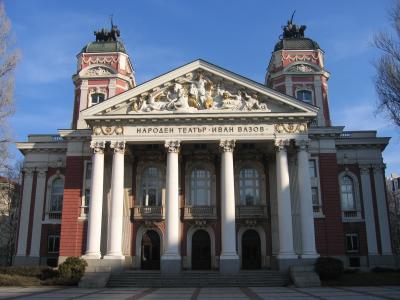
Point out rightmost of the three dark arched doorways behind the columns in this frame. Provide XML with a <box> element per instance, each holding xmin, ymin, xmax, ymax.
<box><xmin>242</xmin><ymin>229</ymin><xmax>261</xmax><ymax>270</ymax></box>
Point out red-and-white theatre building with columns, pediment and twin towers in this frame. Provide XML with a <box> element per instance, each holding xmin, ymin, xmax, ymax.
<box><xmin>15</xmin><ymin>22</ymin><xmax>394</xmax><ymax>273</ymax></box>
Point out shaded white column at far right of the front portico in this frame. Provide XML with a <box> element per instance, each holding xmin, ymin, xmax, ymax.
<box><xmin>296</xmin><ymin>140</ymin><xmax>319</xmax><ymax>258</ymax></box>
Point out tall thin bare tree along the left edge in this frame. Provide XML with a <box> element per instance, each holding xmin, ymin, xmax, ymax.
<box><xmin>0</xmin><ymin>0</ymin><xmax>19</xmax><ymax>174</ymax></box>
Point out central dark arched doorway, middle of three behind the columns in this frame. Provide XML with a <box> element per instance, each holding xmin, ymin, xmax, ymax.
<box><xmin>192</xmin><ymin>230</ymin><xmax>211</xmax><ymax>270</ymax></box>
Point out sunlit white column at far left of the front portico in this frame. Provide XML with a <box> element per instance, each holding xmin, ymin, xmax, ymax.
<box><xmin>84</xmin><ymin>141</ymin><xmax>105</xmax><ymax>259</ymax></box>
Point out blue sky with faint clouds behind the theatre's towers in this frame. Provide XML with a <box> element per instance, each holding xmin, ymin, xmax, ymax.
<box><xmin>5</xmin><ymin>0</ymin><xmax>400</xmax><ymax>174</ymax></box>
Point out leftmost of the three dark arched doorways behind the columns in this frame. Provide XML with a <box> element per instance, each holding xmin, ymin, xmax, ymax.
<box><xmin>141</xmin><ymin>230</ymin><xmax>160</xmax><ymax>270</ymax></box>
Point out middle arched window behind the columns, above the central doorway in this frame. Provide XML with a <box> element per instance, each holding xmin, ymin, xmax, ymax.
<box><xmin>187</xmin><ymin>168</ymin><xmax>211</xmax><ymax>206</ymax></box>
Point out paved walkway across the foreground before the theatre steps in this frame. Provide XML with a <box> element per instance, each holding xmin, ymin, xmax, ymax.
<box><xmin>0</xmin><ymin>286</ymin><xmax>400</xmax><ymax>300</ymax></box>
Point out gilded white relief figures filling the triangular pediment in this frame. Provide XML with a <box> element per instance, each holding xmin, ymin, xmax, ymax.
<box><xmin>128</xmin><ymin>72</ymin><xmax>270</xmax><ymax>113</ymax></box>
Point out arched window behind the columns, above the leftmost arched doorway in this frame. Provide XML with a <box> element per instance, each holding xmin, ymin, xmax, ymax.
<box><xmin>142</xmin><ymin>166</ymin><xmax>164</xmax><ymax>206</ymax></box>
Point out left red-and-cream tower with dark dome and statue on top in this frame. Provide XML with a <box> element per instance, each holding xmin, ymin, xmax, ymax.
<box><xmin>72</xmin><ymin>22</ymin><xmax>136</xmax><ymax>129</ymax></box>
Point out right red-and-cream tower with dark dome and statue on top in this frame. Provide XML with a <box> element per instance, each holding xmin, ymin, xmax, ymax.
<box><xmin>265</xmin><ymin>13</ymin><xmax>331</xmax><ymax>126</ymax></box>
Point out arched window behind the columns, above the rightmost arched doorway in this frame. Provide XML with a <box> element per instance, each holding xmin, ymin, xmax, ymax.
<box><xmin>239</xmin><ymin>168</ymin><xmax>261</xmax><ymax>205</ymax></box>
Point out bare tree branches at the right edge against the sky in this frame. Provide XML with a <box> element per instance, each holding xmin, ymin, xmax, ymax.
<box><xmin>374</xmin><ymin>0</ymin><xmax>400</xmax><ymax>127</ymax></box>
